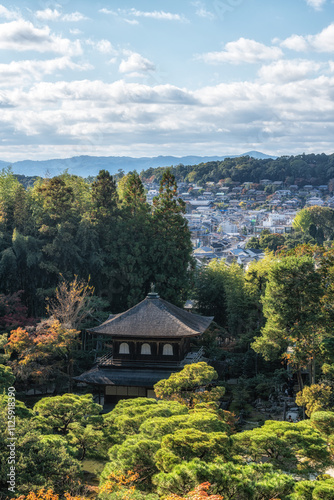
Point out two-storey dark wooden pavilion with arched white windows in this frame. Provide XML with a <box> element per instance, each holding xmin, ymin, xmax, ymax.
<box><xmin>75</xmin><ymin>292</ymin><xmax>213</xmax><ymax>403</ymax></box>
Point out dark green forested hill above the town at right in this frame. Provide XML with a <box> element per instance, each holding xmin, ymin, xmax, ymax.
<box><xmin>140</xmin><ymin>153</ymin><xmax>334</xmax><ymax>185</ymax></box>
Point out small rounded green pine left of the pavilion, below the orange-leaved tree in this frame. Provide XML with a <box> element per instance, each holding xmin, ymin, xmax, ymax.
<box><xmin>34</xmin><ymin>394</ymin><xmax>102</xmax><ymax>435</ymax></box>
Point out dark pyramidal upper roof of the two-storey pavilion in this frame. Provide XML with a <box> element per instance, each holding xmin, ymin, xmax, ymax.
<box><xmin>90</xmin><ymin>292</ymin><xmax>213</xmax><ymax>338</ymax></box>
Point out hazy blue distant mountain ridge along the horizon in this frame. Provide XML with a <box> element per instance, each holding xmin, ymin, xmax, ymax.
<box><xmin>0</xmin><ymin>151</ymin><xmax>276</xmax><ymax>177</ymax></box>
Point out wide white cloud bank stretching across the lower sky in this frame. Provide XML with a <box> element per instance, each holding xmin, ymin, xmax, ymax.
<box><xmin>0</xmin><ymin>76</ymin><xmax>334</xmax><ymax>156</ymax></box>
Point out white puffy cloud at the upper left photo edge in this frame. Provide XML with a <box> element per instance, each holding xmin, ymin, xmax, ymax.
<box><xmin>0</xmin><ymin>19</ymin><xmax>82</xmax><ymax>56</ymax></box>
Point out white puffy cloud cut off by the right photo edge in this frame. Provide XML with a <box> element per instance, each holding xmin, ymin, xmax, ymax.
<box><xmin>281</xmin><ymin>23</ymin><xmax>334</xmax><ymax>52</ymax></box>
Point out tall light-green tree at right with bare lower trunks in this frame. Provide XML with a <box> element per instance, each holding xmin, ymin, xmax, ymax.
<box><xmin>252</xmin><ymin>255</ymin><xmax>325</xmax><ymax>389</ymax></box>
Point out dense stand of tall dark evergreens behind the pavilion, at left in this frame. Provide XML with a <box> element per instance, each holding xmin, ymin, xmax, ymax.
<box><xmin>0</xmin><ymin>170</ymin><xmax>192</xmax><ymax>316</ymax></box>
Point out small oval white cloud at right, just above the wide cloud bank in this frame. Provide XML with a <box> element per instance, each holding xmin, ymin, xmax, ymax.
<box><xmin>258</xmin><ymin>59</ymin><xmax>321</xmax><ymax>83</ymax></box>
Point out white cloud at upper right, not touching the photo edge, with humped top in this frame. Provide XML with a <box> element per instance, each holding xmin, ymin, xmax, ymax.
<box><xmin>198</xmin><ymin>38</ymin><xmax>283</xmax><ymax>64</ymax></box>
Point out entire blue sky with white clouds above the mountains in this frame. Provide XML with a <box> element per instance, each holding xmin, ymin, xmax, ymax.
<box><xmin>0</xmin><ymin>0</ymin><xmax>334</xmax><ymax>162</ymax></box>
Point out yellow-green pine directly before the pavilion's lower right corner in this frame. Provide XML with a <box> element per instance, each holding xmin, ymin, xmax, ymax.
<box><xmin>154</xmin><ymin>361</ymin><xmax>225</xmax><ymax>407</ymax></box>
